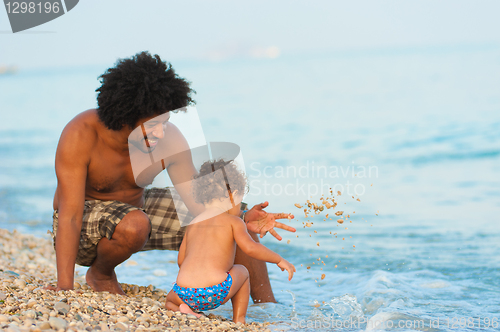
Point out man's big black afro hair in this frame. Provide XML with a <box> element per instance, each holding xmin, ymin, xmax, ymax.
<box><xmin>96</xmin><ymin>52</ymin><xmax>196</xmax><ymax>130</ymax></box>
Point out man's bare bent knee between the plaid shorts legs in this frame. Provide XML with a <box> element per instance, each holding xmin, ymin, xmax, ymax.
<box><xmin>115</xmin><ymin>210</ymin><xmax>151</xmax><ymax>243</ymax></box>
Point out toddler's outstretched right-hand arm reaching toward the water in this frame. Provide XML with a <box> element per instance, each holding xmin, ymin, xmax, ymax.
<box><xmin>232</xmin><ymin>218</ymin><xmax>295</xmax><ymax>280</ymax></box>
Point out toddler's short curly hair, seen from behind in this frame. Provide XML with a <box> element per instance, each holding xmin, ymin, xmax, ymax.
<box><xmin>193</xmin><ymin>159</ymin><xmax>248</xmax><ymax>204</ymax></box>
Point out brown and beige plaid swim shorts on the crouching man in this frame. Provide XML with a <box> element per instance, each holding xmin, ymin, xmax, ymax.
<box><xmin>52</xmin><ymin>188</ymin><xmax>192</xmax><ymax>266</ymax></box>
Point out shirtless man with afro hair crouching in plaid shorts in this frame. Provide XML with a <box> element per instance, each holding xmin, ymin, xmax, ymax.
<box><xmin>48</xmin><ymin>52</ymin><xmax>295</xmax><ymax>302</ymax></box>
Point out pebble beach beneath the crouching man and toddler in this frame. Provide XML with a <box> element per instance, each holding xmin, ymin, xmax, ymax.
<box><xmin>0</xmin><ymin>229</ymin><xmax>269</xmax><ymax>332</ymax></box>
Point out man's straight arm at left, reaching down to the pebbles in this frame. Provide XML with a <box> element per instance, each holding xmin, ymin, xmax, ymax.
<box><xmin>55</xmin><ymin>120</ymin><xmax>93</xmax><ymax>290</ymax></box>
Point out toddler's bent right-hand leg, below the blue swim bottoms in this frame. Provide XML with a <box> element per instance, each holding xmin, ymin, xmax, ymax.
<box><xmin>223</xmin><ymin>264</ymin><xmax>250</xmax><ymax>323</ymax></box>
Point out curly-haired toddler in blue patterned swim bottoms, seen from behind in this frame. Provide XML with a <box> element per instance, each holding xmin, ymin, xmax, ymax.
<box><xmin>165</xmin><ymin>159</ymin><xmax>295</xmax><ymax>323</ymax></box>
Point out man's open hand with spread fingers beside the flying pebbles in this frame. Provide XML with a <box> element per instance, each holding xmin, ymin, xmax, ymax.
<box><xmin>245</xmin><ymin>202</ymin><xmax>296</xmax><ymax>241</ymax></box>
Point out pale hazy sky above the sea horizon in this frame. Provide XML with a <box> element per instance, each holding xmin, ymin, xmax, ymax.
<box><xmin>0</xmin><ymin>0</ymin><xmax>500</xmax><ymax>69</ymax></box>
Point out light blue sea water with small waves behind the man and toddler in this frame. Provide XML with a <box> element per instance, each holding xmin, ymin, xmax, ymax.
<box><xmin>0</xmin><ymin>46</ymin><xmax>500</xmax><ymax>331</ymax></box>
